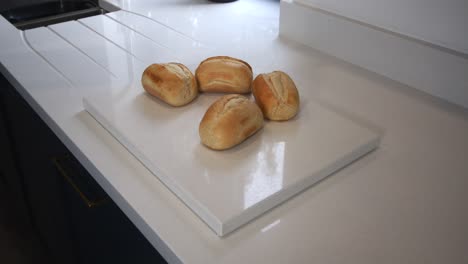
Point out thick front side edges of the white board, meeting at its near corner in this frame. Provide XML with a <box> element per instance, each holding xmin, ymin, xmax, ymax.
<box><xmin>83</xmin><ymin>98</ymin><xmax>380</xmax><ymax>236</ymax></box>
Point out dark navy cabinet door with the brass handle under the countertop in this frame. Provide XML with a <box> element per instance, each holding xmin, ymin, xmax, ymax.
<box><xmin>56</xmin><ymin>156</ymin><xmax>166</xmax><ymax>264</ymax></box>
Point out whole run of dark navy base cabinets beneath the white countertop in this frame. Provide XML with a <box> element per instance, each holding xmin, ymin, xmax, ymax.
<box><xmin>0</xmin><ymin>77</ymin><xmax>165</xmax><ymax>264</ymax></box>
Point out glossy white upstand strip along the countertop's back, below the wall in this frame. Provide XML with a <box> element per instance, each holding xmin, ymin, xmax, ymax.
<box><xmin>280</xmin><ymin>1</ymin><xmax>468</xmax><ymax>108</ymax></box>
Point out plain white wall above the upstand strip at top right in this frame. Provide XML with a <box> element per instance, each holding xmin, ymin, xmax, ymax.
<box><xmin>295</xmin><ymin>0</ymin><xmax>468</xmax><ymax>54</ymax></box>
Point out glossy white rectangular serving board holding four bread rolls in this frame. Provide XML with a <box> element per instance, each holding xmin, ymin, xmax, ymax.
<box><xmin>83</xmin><ymin>85</ymin><xmax>379</xmax><ymax>236</ymax></box>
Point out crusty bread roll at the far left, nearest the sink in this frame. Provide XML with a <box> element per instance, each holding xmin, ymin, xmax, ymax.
<box><xmin>141</xmin><ymin>62</ymin><xmax>198</xmax><ymax>106</ymax></box>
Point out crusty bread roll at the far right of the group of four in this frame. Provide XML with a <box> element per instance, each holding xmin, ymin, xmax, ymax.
<box><xmin>252</xmin><ymin>71</ymin><xmax>299</xmax><ymax>121</ymax></box>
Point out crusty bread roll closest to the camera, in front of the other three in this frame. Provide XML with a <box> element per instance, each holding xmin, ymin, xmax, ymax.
<box><xmin>199</xmin><ymin>94</ymin><xmax>263</xmax><ymax>150</ymax></box>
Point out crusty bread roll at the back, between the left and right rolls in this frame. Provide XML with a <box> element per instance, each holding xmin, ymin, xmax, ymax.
<box><xmin>195</xmin><ymin>56</ymin><xmax>253</xmax><ymax>93</ymax></box>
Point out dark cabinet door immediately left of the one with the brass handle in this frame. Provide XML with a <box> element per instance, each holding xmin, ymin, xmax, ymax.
<box><xmin>4</xmin><ymin>81</ymin><xmax>77</xmax><ymax>264</ymax></box>
